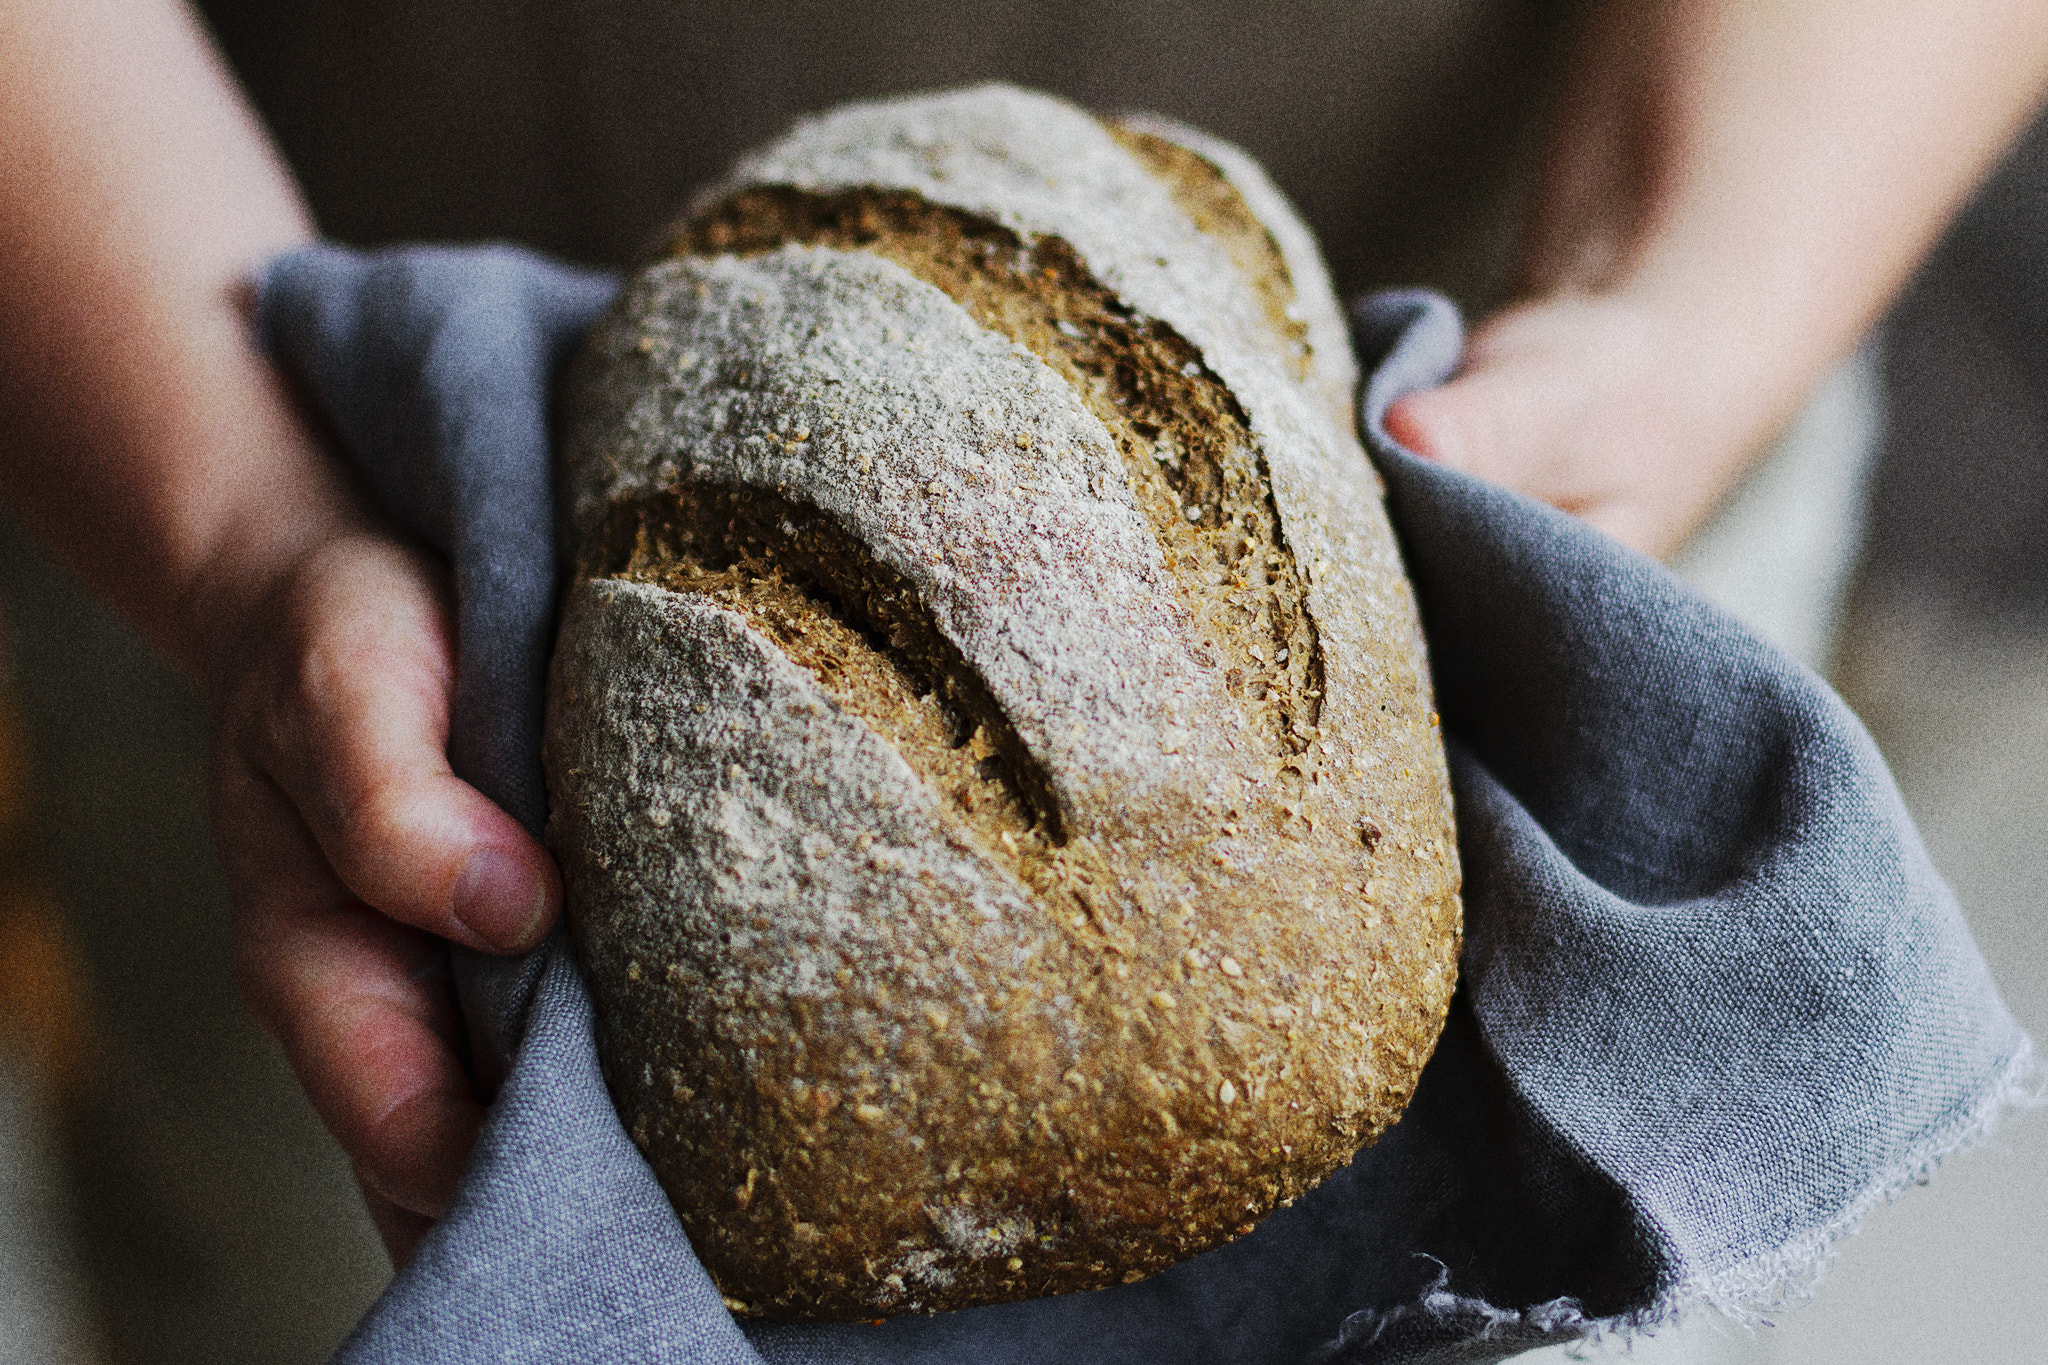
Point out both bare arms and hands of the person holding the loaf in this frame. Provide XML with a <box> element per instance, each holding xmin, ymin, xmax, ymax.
<box><xmin>0</xmin><ymin>0</ymin><xmax>2048</xmax><ymax>1263</ymax></box>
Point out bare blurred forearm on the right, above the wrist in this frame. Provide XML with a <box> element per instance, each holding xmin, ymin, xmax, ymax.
<box><xmin>1520</xmin><ymin>0</ymin><xmax>2048</xmax><ymax>438</ymax></box>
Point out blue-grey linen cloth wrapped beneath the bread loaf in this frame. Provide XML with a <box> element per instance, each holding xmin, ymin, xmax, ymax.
<box><xmin>260</xmin><ymin>248</ymin><xmax>2032</xmax><ymax>1365</ymax></box>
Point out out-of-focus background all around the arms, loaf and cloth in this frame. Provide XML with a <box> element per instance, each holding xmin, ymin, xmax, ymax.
<box><xmin>0</xmin><ymin>0</ymin><xmax>2048</xmax><ymax>1363</ymax></box>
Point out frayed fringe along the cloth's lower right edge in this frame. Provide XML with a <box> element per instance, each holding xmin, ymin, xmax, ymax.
<box><xmin>1311</xmin><ymin>1033</ymin><xmax>2048</xmax><ymax>1361</ymax></box>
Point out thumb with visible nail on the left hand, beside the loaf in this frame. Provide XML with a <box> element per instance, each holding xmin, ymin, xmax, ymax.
<box><xmin>250</xmin><ymin>540</ymin><xmax>561</xmax><ymax>952</ymax></box>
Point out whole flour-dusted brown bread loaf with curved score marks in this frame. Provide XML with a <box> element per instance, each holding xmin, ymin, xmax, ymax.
<box><xmin>547</xmin><ymin>86</ymin><xmax>1460</xmax><ymax>1318</ymax></box>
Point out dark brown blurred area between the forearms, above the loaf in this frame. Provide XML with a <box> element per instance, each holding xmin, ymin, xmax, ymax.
<box><xmin>201</xmin><ymin>0</ymin><xmax>1569</xmax><ymax>301</ymax></box>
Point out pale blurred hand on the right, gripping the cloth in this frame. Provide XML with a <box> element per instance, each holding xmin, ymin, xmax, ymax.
<box><xmin>1386</xmin><ymin>295</ymin><xmax>1782</xmax><ymax>559</ymax></box>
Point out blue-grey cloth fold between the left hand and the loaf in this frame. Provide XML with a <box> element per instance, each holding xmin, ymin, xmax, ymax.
<box><xmin>256</xmin><ymin>246</ymin><xmax>618</xmax><ymax>1095</ymax></box>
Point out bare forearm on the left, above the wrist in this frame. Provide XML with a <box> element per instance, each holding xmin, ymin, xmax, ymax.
<box><xmin>0</xmin><ymin>0</ymin><xmax>352</xmax><ymax>681</ymax></box>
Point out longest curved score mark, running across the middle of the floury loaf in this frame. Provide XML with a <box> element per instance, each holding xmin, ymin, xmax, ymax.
<box><xmin>670</xmin><ymin>178</ymin><xmax>1323</xmax><ymax>772</ymax></box>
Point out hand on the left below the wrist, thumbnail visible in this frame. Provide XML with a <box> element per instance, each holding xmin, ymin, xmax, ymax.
<box><xmin>211</xmin><ymin>530</ymin><xmax>561</xmax><ymax>1265</ymax></box>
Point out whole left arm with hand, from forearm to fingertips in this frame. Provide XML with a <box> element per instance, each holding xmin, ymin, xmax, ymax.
<box><xmin>0</xmin><ymin>0</ymin><xmax>561</xmax><ymax>1259</ymax></box>
